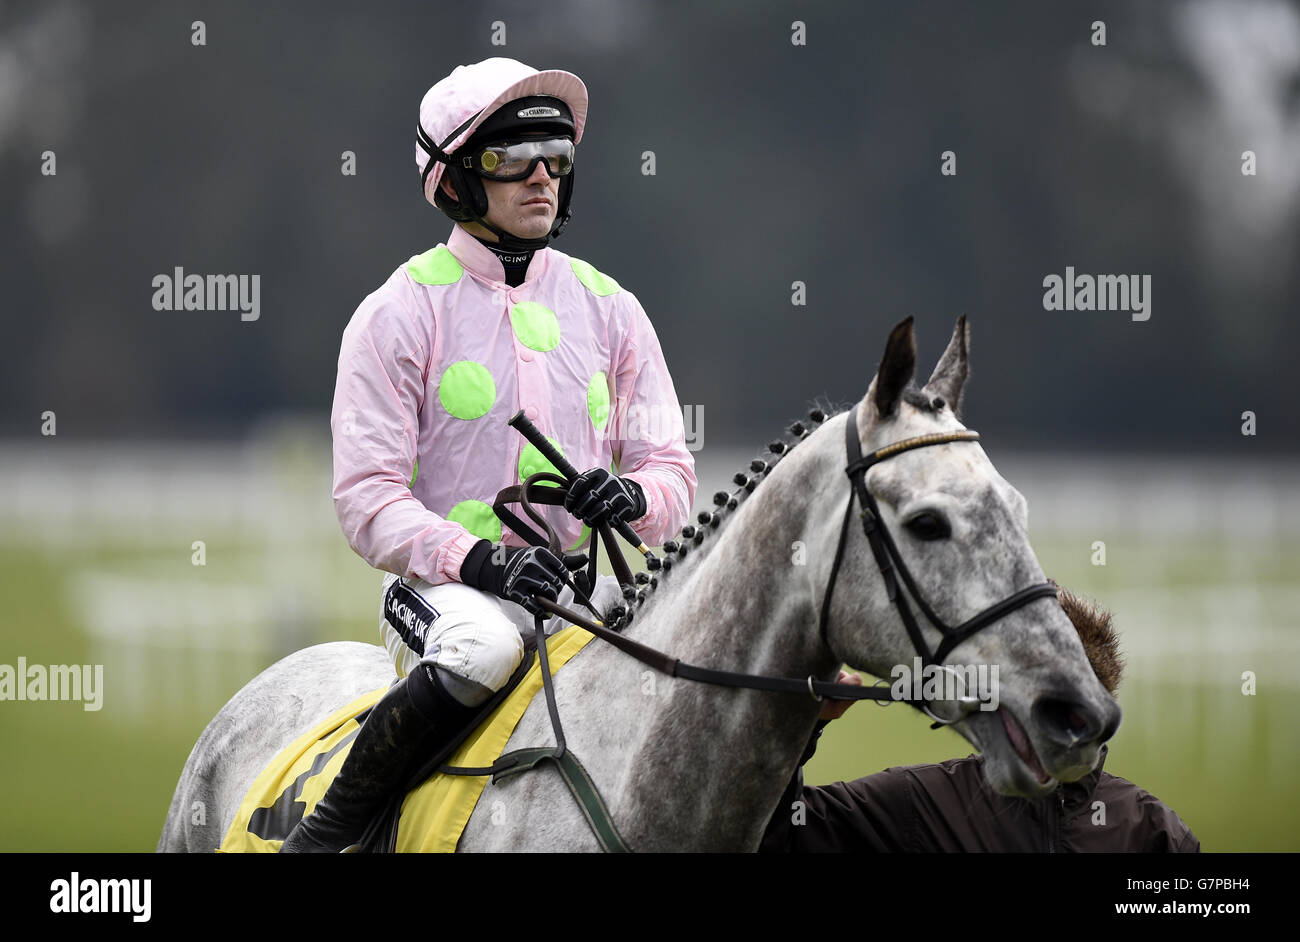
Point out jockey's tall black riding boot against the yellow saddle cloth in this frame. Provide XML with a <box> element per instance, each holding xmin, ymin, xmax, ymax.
<box><xmin>280</xmin><ymin>664</ymin><xmax>476</xmax><ymax>854</ymax></box>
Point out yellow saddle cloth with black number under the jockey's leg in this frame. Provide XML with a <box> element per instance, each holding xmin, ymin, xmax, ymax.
<box><xmin>217</xmin><ymin>626</ymin><xmax>594</xmax><ymax>854</ymax></box>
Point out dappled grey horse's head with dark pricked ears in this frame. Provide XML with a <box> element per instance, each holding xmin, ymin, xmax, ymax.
<box><xmin>810</xmin><ymin>317</ymin><xmax>1119</xmax><ymax>796</ymax></box>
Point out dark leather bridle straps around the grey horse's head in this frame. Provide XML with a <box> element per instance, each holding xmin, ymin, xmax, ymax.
<box><xmin>820</xmin><ymin>407</ymin><xmax>1057</xmax><ymax>665</ymax></box>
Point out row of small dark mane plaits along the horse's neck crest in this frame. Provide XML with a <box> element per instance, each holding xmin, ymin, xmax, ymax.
<box><xmin>608</xmin><ymin>407</ymin><xmax>835</xmax><ymax>630</ymax></box>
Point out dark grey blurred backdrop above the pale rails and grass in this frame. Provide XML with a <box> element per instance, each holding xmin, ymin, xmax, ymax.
<box><xmin>0</xmin><ymin>0</ymin><xmax>1300</xmax><ymax>452</ymax></box>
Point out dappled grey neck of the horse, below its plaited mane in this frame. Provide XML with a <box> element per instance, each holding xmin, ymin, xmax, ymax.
<box><xmin>592</xmin><ymin>444</ymin><xmax>836</xmax><ymax>850</ymax></box>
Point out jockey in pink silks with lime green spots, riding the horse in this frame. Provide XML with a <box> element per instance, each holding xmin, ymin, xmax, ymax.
<box><xmin>281</xmin><ymin>58</ymin><xmax>696</xmax><ymax>852</ymax></box>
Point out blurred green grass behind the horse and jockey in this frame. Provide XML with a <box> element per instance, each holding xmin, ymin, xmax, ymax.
<box><xmin>0</xmin><ymin>535</ymin><xmax>1300</xmax><ymax>851</ymax></box>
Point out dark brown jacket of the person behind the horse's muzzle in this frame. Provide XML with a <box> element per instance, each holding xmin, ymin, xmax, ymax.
<box><xmin>759</xmin><ymin>750</ymin><xmax>1201</xmax><ymax>854</ymax></box>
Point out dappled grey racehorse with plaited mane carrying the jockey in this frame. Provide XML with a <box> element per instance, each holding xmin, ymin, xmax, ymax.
<box><xmin>159</xmin><ymin>318</ymin><xmax>1119</xmax><ymax>851</ymax></box>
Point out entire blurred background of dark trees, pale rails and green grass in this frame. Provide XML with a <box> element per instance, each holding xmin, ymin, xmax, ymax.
<box><xmin>0</xmin><ymin>0</ymin><xmax>1300</xmax><ymax>851</ymax></box>
